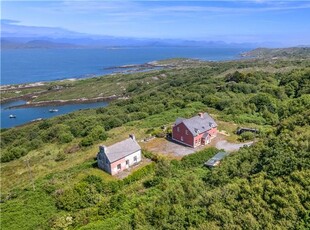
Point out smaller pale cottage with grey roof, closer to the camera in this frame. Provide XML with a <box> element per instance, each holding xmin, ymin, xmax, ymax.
<box><xmin>97</xmin><ymin>134</ymin><xmax>141</xmax><ymax>175</ymax></box>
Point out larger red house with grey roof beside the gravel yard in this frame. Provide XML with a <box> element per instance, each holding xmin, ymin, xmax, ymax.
<box><xmin>172</xmin><ymin>113</ymin><xmax>217</xmax><ymax>148</ymax></box>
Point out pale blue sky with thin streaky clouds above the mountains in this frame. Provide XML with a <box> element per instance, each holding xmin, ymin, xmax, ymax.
<box><xmin>1</xmin><ymin>0</ymin><xmax>310</xmax><ymax>45</ymax></box>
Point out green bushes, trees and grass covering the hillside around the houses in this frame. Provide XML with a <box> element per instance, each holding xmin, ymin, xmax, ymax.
<box><xmin>1</xmin><ymin>51</ymin><xmax>310</xmax><ymax>229</ymax></box>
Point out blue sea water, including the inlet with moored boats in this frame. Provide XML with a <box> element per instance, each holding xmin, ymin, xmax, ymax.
<box><xmin>1</xmin><ymin>47</ymin><xmax>250</xmax><ymax>128</ymax></box>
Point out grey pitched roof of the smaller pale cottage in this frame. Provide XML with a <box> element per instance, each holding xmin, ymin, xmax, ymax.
<box><xmin>101</xmin><ymin>138</ymin><xmax>141</xmax><ymax>163</ymax></box>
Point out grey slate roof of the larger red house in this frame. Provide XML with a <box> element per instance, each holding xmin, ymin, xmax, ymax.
<box><xmin>175</xmin><ymin>113</ymin><xmax>217</xmax><ymax>136</ymax></box>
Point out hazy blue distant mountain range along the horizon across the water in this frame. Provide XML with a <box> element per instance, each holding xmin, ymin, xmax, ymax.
<box><xmin>1</xmin><ymin>20</ymin><xmax>263</xmax><ymax>49</ymax></box>
